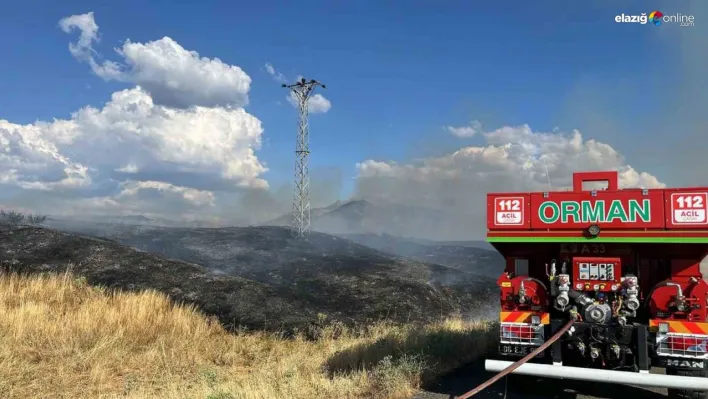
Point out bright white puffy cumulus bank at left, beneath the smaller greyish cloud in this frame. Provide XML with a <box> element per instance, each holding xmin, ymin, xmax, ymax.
<box><xmin>0</xmin><ymin>87</ymin><xmax>267</xmax><ymax>193</ymax></box>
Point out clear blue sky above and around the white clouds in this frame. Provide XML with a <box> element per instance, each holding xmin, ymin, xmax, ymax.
<box><xmin>0</xmin><ymin>0</ymin><xmax>699</xmax><ymax>228</ymax></box>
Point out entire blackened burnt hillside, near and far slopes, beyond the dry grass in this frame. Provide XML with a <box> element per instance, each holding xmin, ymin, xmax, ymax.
<box><xmin>0</xmin><ymin>227</ymin><xmax>496</xmax><ymax>329</ymax></box>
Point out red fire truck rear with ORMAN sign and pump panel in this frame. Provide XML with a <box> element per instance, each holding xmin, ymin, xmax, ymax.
<box><xmin>486</xmin><ymin>171</ymin><xmax>708</xmax><ymax>398</ymax></box>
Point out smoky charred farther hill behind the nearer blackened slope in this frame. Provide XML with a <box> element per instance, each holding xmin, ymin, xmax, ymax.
<box><xmin>98</xmin><ymin>227</ymin><xmax>493</xmax><ymax>292</ymax></box>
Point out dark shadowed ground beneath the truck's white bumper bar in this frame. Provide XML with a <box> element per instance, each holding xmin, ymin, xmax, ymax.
<box><xmin>414</xmin><ymin>362</ymin><xmax>667</xmax><ymax>399</ymax></box>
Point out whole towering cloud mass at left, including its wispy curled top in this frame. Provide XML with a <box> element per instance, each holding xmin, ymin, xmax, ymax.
<box><xmin>0</xmin><ymin>13</ymin><xmax>269</xmax><ymax>223</ymax></box>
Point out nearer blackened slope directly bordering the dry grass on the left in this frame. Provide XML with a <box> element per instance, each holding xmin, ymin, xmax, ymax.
<box><xmin>0</xmin><ymin>228</ymin><xmax>316</xmax><ymax>327</ymax></box>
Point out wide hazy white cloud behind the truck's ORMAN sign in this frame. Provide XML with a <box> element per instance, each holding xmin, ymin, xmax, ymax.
<box><xmin>356</xmin><ymin>125</ymin><xmax>665</xmax><ymax>239</ymax></box>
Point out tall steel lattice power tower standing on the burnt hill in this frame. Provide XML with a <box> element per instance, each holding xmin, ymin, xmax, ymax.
<box><xmin>283</xmin><ymin>78</ymin><xmax>327</xmax><ymax>238</ymax></box>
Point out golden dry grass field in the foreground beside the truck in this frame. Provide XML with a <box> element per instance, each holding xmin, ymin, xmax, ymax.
<box><xmin>0</xmin><ymin>274</ymin><xmax>496</xmax><ymax>399</ymax></box>
